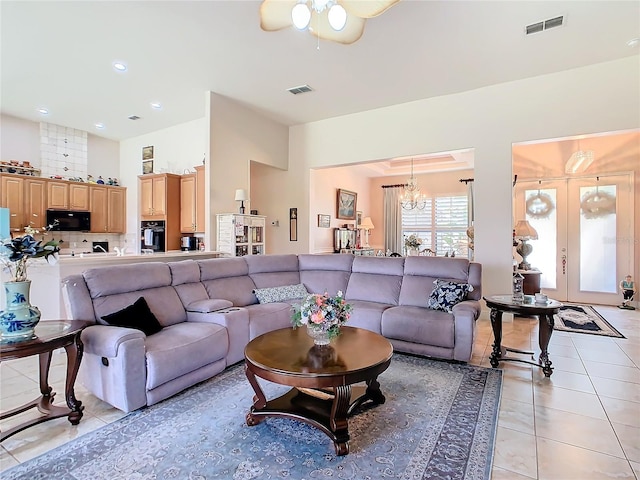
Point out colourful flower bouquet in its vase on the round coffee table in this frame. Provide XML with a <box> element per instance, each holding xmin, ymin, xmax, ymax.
<box><xmin>291</xmin><ymin>291</ymin><xmax>353</xmax><ymax>345</ymax></box>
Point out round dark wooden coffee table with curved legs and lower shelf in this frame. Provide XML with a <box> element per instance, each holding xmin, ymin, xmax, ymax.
<box><xmin>244</xmin><ymin>327</ymin><xmax>393</xmax><ymax>455</ymax></box>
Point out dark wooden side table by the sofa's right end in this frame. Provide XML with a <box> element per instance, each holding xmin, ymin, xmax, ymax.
<box><xmin>483</xmin><ymin>295</ymin><xmax>562</xmax><ymax>377</ymax></box>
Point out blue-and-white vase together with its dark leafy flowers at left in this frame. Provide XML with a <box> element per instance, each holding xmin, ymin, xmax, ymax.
<box><xmin>0</xmin><ymin>227</ymin><xmax>60</xmax><ymax>338</ymax></box>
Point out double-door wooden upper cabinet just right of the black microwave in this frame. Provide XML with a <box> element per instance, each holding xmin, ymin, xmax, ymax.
<box><xmin>89</xmin><ymin>185</ymin><xmax>127</xmax><ymax>233</ymax></box>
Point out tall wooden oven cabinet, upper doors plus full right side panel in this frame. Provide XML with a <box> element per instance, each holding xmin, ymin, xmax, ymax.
<box><xmin>138</xmin><ymin>173</ymin><xmax>181</xmax><ymax>251</ymax></box>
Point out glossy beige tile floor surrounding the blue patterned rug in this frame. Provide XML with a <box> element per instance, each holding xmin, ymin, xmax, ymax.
<box><xmin>0</xmin><ymin>307</ymin><xmax>640</xmax><ymax>480</ymax></box>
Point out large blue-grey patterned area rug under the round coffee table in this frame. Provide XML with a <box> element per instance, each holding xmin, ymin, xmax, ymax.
<box><xmin>2</xmin><ymin>354</ymin><xmax>502</xmax><ymax>480</ymax></box>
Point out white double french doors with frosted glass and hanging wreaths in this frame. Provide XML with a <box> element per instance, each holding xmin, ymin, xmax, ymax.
<box><xmin>514</xmin><ymin>174</ymin><xmax>634</xmax><ymax>305</ymax></box>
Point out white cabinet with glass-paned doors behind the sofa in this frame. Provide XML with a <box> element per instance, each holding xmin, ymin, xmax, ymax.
<box><xmin>216</xmin><ymin>213</ymin><xmax>266</xmax><ymax>257</ymax></box>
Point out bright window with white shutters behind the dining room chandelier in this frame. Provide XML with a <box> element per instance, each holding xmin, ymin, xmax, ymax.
<box><xmin>402</xmin><ymin>195</ymin><xmax>469</xmax><ymax>256</ymax></box>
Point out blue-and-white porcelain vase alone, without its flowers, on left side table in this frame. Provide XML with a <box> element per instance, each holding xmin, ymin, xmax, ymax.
<box><xmin>0</xmin><ymin>280</ymin><xmax>40</xmax><ymax>338</ymax></box>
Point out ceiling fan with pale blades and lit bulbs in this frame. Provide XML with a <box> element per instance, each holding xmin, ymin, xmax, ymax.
<box><xmin>260</xmin><ymin>0</ymin><xmax>400</xmax><ymax>44</ymax></box>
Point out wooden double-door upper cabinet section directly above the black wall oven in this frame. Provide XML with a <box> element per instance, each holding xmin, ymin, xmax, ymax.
<box><xmin>138</xmin><ymin>173</ymin><xmax>180</xmax><ymax>220</ymax></box>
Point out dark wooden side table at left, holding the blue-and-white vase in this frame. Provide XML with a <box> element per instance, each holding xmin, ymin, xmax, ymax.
<box><xmin>0</xmin><ymin>320</ymin><xmax>91</xmax><ymax>442</ymax></box>
